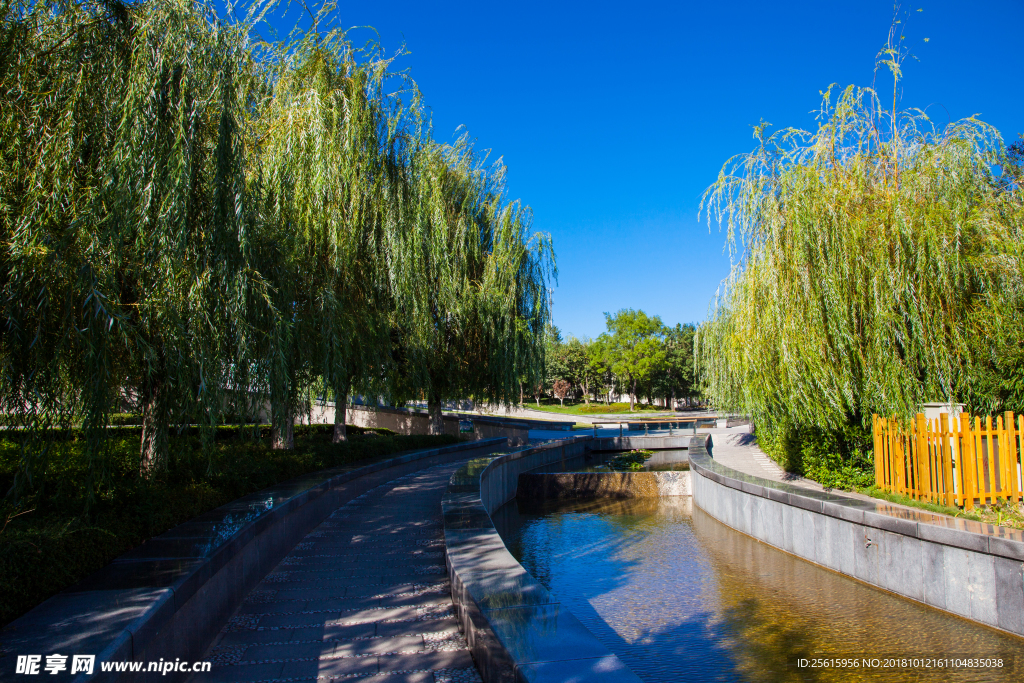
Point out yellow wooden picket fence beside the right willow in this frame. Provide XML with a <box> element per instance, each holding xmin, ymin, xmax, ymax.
<box><xmin>872</xmin><ymin>413</ymin><xmax>1024</xmax><ymax>510</ymax></box>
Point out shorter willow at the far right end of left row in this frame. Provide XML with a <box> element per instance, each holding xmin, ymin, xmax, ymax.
<box><xmin>394</xmin><ymin>135</ymin><xmax>554</xmax><ymax>433</ymax></box>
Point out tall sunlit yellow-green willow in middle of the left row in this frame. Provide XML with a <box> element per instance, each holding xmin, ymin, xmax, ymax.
<box><xmin>251</xmin><ymin>24</ymin><xmax>403</xmax><ymax>447</ymax></box>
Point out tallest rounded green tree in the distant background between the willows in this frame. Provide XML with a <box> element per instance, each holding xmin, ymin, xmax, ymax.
<box><xmin>604</xmin><ymin>308</ymin><xmax>666</xmax><ymax>412</ymax></box>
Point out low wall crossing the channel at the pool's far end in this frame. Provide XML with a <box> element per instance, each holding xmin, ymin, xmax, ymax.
<box><xmin>516</xmin><ymin>471</ymin><xmax>690</xmax><ymax>501</ymax></box>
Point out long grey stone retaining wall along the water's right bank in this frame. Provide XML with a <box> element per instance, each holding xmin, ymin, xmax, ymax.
<box><xmin>689</xmin><ymin>438</ymin><xmax>1024</xmax><ymax>636</ymax></box>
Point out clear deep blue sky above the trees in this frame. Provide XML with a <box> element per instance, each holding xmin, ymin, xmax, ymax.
<box><xmin>266</xmin><ymin>0</ymin><xmax>1024</xmax><ymax>337</ymax></box>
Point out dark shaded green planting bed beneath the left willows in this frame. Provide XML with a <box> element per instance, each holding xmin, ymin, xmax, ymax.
<box><xmin>0</xmin><ymin>425</ymin><xmax>459</xmax><ymax>625</ymax></box>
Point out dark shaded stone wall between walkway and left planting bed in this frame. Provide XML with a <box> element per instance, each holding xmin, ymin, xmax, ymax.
<box><xmin>0</xmin><ymin>438</ymin><xmax>507</xmax><ymax>683</ymax></box>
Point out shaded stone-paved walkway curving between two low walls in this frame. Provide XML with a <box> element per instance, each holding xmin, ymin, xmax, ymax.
<box><xmin>202</xmin><ymin>462</ymin><xmax>480</xmax><ymax>683</ymax></box>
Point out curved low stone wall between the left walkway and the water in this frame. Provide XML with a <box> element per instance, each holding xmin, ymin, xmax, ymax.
<box><xmin>441</xmin><ymin>436</ymin><xmax>640</xmax><ymax>683</ymax></box>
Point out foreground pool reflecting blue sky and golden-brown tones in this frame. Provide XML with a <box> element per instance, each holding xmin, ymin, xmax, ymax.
<box><xmin>495</xmin><ymin>497</ymin><xmax>1024</xmax><ymax>683</ymax></box>
